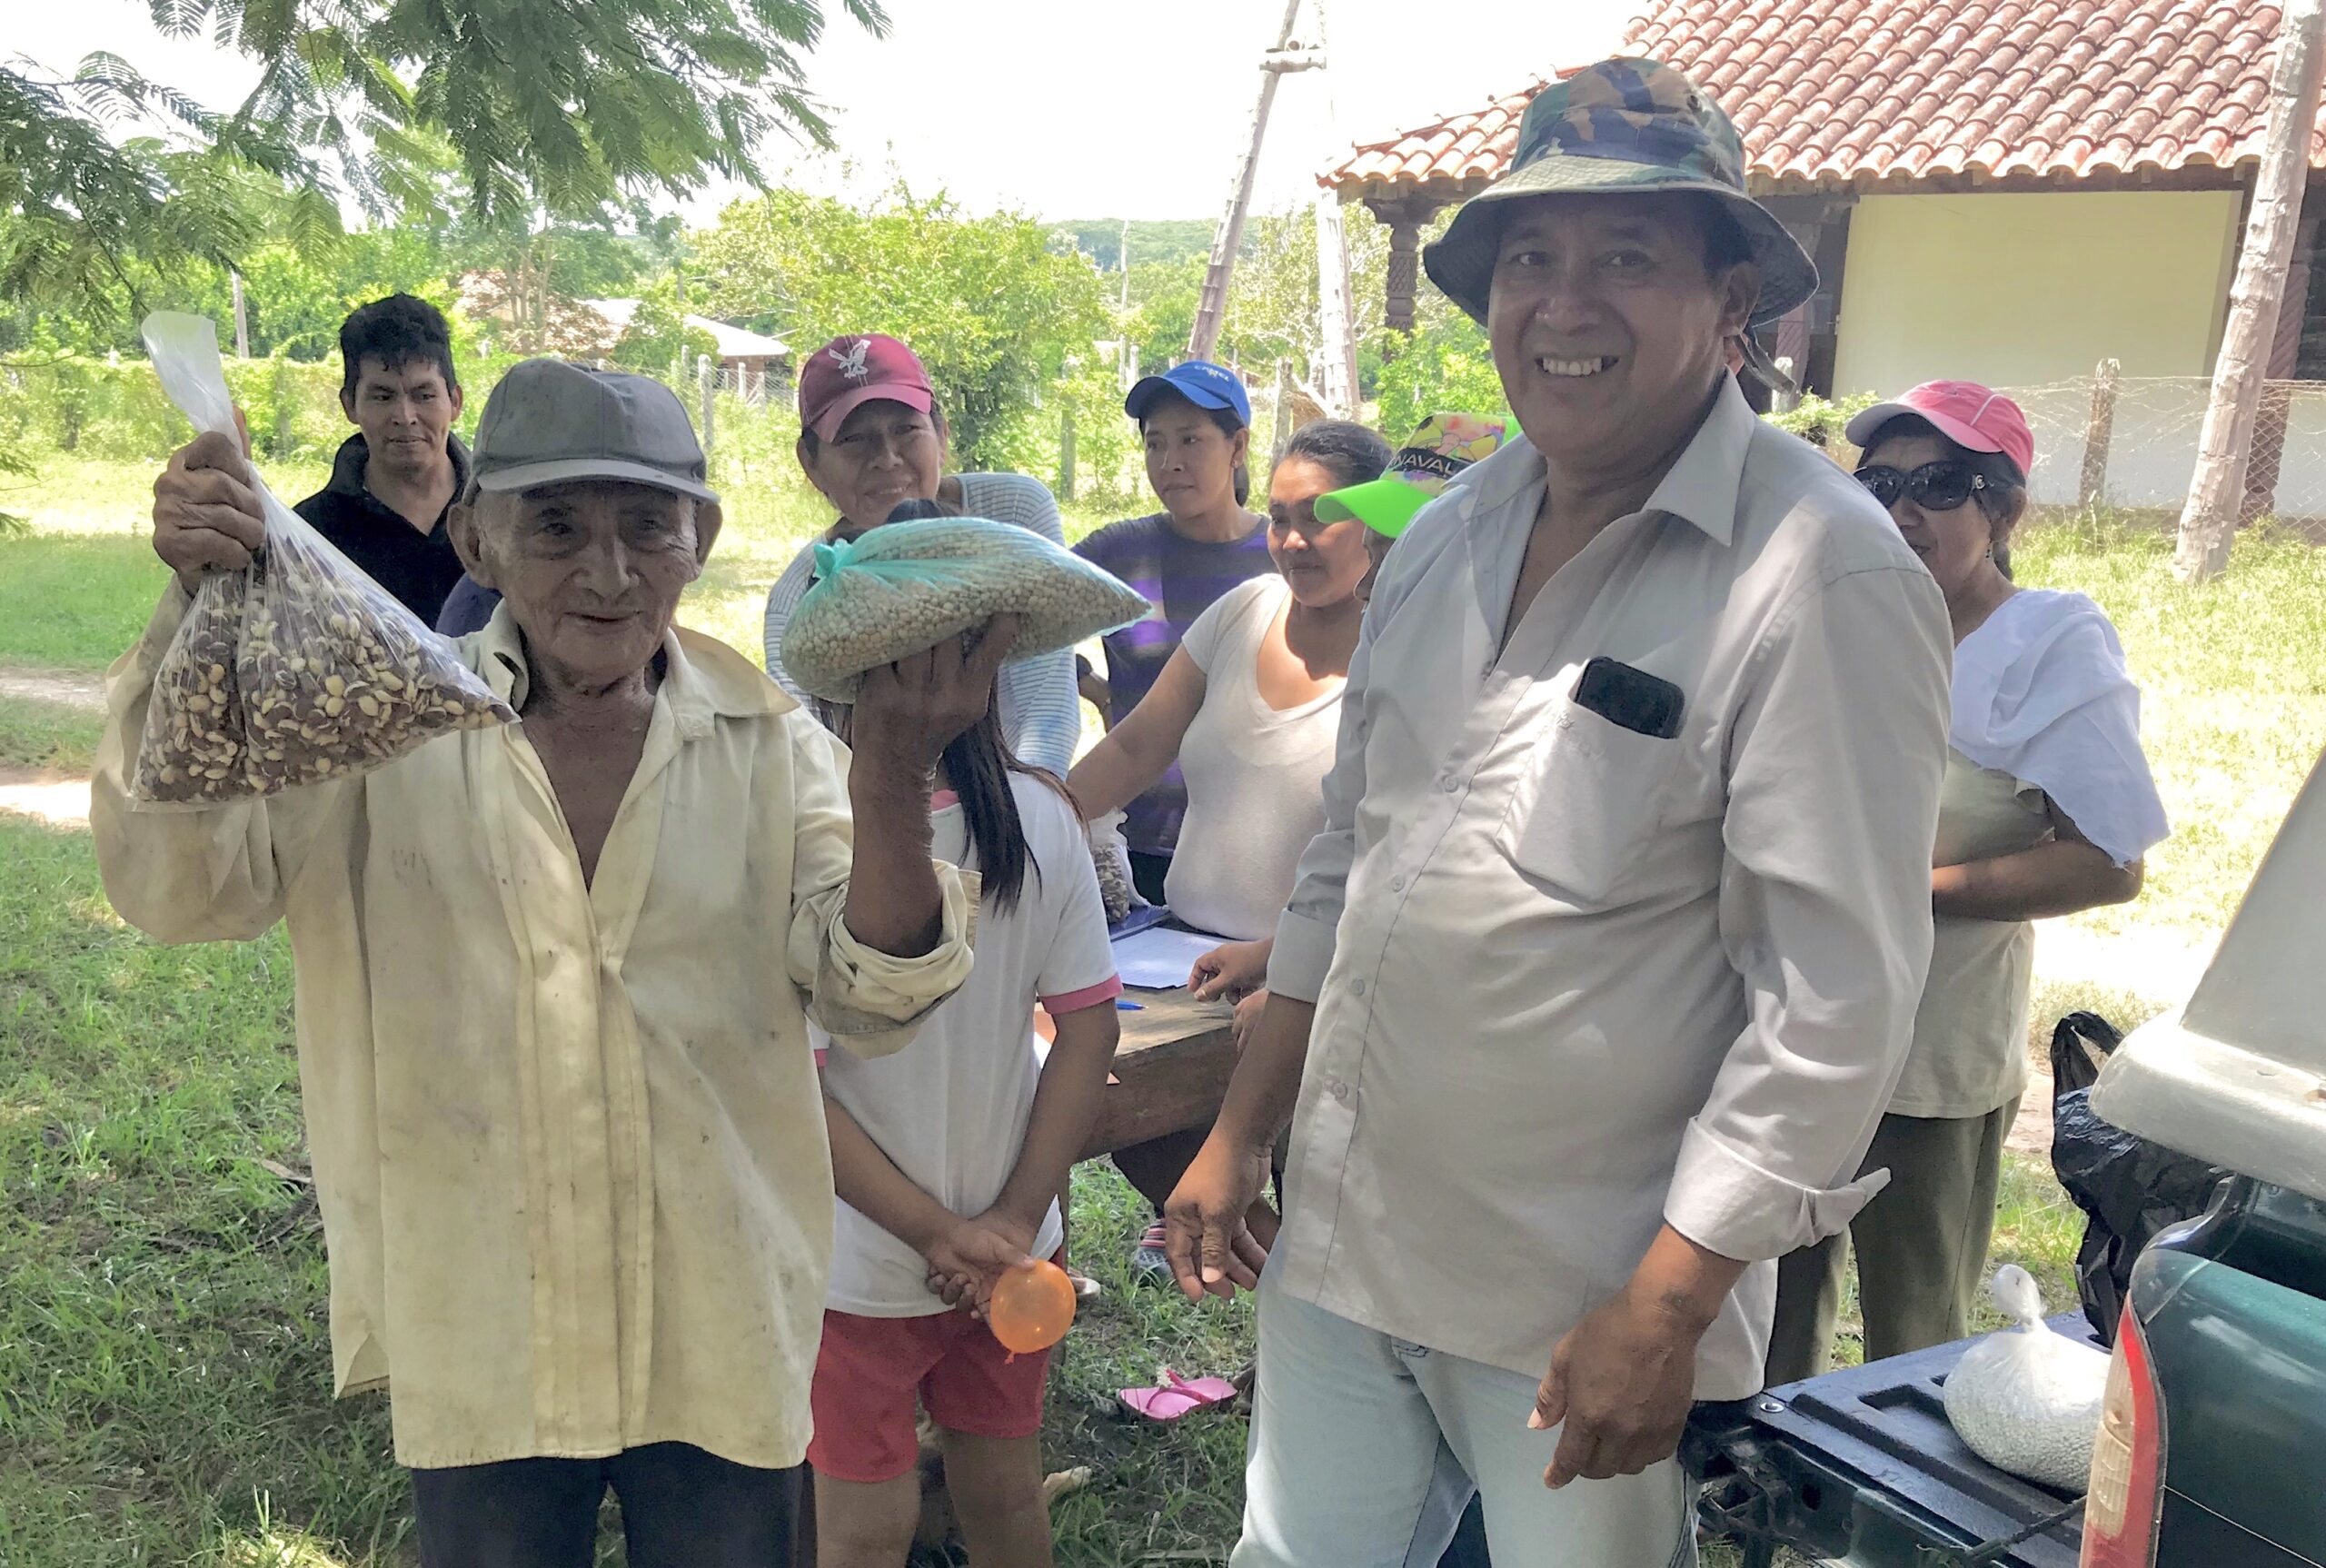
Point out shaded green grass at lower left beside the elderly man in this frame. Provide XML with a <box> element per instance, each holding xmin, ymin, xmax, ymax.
<box><xmin>0</xmin><ymin>817</ymin><xmax>404</xmax><ymax>1568</ymax></box>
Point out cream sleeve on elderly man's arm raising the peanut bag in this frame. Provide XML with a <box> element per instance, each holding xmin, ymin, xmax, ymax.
<box><xmin>88</xmin><ymin>584</ymin><xmax>361</xmax><ymax>942</ymax></box>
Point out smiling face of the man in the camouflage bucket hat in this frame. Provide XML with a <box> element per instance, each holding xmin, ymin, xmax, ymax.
<box><xmin>1486</xmin><ymin>194</ymin><xmax>1761</xmax><ymax>472</ymax></box>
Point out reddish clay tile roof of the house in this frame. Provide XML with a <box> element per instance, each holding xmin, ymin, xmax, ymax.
<box><xmin>1319</xmin><ymin>0</ymin><xmax>2326</xmax><ymax>200</ymax></box>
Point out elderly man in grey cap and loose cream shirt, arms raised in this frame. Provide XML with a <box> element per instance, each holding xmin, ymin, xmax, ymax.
<box><xmin>106</xmin><ymin>361</ymin><xmax>1012</xmax><ymax>1568</ymax></box>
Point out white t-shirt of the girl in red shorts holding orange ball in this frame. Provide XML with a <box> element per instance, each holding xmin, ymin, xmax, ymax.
<box><xmin>810</xmin><ymin>772</ymin><xmax>1121</xmax><ymax>1316</ymax></box>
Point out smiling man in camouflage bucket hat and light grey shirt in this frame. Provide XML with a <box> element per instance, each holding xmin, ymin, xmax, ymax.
<box><xmin>1168</xmin><ymin>61</ymin><xmax>1949</xmax><ymax>1568</ymax></box>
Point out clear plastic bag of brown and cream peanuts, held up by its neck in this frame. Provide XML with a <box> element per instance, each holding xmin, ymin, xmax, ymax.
<box><xmin>130</xmin><ymin>312</ymin><xmax>516</xmax><ymax>808</ymax></box>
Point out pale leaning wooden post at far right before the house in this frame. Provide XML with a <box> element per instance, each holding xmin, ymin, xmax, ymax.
<box><xmin>2172</xmin><ymin>0</ymin><xmax>2326</xmax><ymax>581</ymax></box>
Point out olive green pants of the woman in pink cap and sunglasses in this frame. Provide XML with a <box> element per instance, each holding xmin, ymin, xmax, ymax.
<box><xmin>1768</xmin><ymin>1098</ymin><xmax>2019</xmax><ymax>1389</ymax></box>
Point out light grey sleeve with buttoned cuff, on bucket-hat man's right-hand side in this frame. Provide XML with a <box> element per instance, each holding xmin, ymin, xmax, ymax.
<box><xmin>1665</xmin><ymin>565</ymin><xmax>1952</xmax><ymax>1261</ymax></box>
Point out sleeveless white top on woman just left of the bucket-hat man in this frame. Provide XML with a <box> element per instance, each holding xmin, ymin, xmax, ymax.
<box><xmin>1163</xmin><ymin>575</ymin><xmax>1347</xmax><ymax>942</ymax></box>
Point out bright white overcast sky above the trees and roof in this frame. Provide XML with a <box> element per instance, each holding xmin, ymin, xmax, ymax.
<box><xmin>0</xmin><ymin>0</ymin><xmax>1640</xmax><ymax>221</ymax></box>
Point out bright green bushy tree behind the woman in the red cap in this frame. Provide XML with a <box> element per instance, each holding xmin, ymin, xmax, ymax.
<box><xmin>686</xmin><ymin>184</ymin><xmax>1114</xmax><ymax>468</ymax></box>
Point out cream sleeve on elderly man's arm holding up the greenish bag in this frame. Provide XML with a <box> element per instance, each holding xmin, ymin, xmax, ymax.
<box><xmin>784</xmin><ymin>714</ymin><xmax>977</xmax><ymax>1057</ymax></box>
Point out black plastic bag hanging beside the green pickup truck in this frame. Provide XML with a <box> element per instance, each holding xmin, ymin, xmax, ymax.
<box><xmin>2052</xmin><ymin>1012</ymin><xmax>2228</xmax><ymax>1347</ymax></box>
